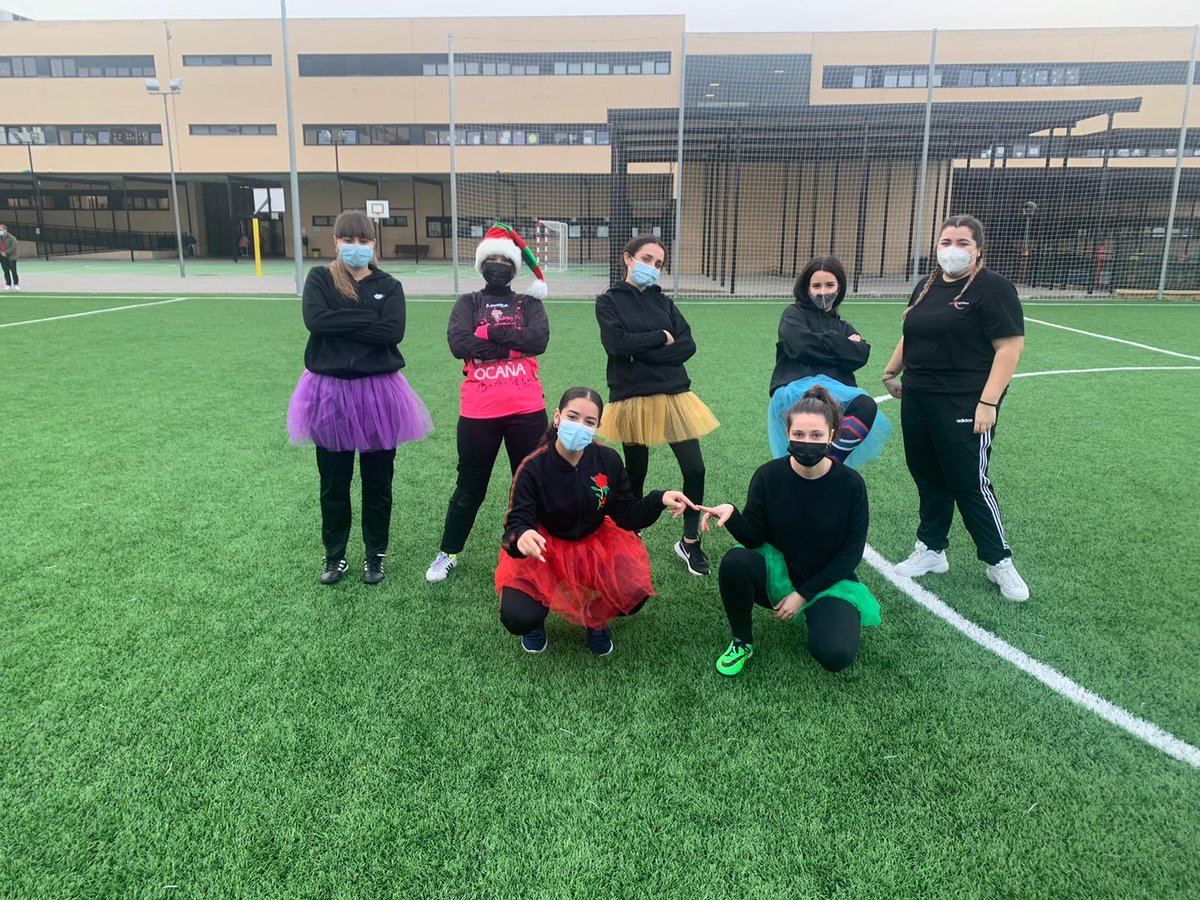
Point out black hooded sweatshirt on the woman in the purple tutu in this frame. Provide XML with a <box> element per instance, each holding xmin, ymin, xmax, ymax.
<box><xmin>302</xmin><ymin>265</ymin><xmax>404</xmax><ymax>378</ymax></box>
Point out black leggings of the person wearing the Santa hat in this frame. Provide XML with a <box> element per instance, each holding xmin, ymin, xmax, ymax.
<box><xmin>442</xmin><ymin>410</ymin><xmax>546</xmax><ymax>553</ymax></box>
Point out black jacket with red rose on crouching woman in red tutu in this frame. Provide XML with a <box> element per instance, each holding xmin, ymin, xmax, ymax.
<box><xmin>500</xmin><ymin>442</ymin><xmax>662</xmax><ymax>559</ymax></box>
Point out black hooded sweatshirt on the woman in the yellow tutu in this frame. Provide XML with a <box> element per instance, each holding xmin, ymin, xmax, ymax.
<box><xmin>596</xmin><ymin>282</ymin><xmax>696</xmax><ymax>402</ymax></box>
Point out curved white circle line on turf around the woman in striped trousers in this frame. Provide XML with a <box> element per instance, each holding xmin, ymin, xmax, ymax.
<box><xmin>863</xmin><ymin>362</ymin><xmax>1200</xmax><ymax>769</ymax></box>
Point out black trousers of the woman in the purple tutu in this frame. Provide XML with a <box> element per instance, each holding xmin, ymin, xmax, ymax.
<box><xmin>317</xmin><ymin>446</ymin><xmax>396</xmax><ymax>559</ymax></box>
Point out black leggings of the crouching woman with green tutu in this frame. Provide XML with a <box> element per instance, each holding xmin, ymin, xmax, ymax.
<box><xmin>719</xmin><ymin>547</ymin><xmax>862</xmax><ymax>672</ymax></box>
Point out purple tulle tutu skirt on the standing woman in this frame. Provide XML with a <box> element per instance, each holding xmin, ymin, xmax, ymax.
<box><xmin>288</xmin><ymin>370</ymin><xmax>433</xmax><ymax>452</ymax></box>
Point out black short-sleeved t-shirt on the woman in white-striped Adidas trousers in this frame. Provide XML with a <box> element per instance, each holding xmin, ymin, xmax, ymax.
<box><xmin>904</xmin><ymin>269</ymin><xmax>1025</xmax><ymax>394</ymax></box>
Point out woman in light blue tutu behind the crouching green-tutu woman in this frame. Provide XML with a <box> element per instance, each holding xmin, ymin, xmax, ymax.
<box><xmin>767</xmin><ymin>257</ymin><xmax>892</xmax><ymax>469</ymax></box>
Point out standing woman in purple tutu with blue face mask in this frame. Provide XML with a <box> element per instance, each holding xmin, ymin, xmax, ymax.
<box><xmin>288</xmin><ymin>211</ymin><xmax>433</xmax><ymax>584</ymax></box>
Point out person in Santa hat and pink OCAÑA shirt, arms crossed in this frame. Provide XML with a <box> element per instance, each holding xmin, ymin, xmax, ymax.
<box><xmin>425</xmin><ymin>222</ymin><xmax>550</xmax><ymax>583</ymax></box>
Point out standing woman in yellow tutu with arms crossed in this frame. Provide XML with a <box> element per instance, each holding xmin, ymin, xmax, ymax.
<box><xmin>596</xmin><ymin>234</ymin><xmax>720</xmax><ymax>576</ymax></box>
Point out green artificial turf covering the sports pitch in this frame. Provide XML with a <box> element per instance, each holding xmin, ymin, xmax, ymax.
<box><xmin>0</xmin><ymin>298</ymin><xmax>1200</xmax><ymax>898</ymax></box>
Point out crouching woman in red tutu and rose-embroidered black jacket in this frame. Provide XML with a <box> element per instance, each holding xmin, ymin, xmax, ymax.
<box><xmin>496</xmin><ymin>388</ymin><xmax>694</xmax><ymax>656</ymax></box>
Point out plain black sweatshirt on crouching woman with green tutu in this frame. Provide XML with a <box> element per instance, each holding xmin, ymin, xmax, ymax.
<box><xmin>726</xmin><ymin>456</ymin><xmax>869</xmax><ymax>600</ymax></box>
